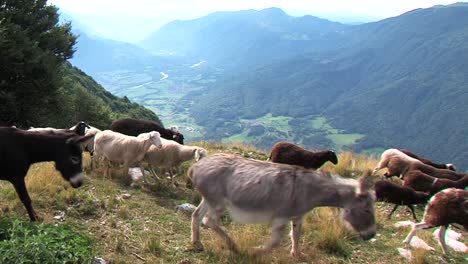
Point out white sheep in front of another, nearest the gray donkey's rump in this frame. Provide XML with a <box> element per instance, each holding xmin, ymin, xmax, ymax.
<box><xmin>138</xmin><ymin>133</ymin><xmax>208</xmax><ymax>183</ymax></box>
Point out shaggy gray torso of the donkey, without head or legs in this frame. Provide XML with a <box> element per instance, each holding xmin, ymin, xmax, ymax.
<box><xmin>189</xmin><ymin>154</ymin><xmax>336</xmax><ymax>223</ymax></box>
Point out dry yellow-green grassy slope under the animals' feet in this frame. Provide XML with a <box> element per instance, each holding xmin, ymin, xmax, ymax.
<box><xmin>0</xmin><ymin>142</ymin><xmax>468</xmax><ymax>263</ymax></box>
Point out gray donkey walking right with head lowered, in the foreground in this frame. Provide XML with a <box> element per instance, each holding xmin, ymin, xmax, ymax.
<box><xmin>188</xmin><ymin>154</ymin><xmax>376</xmax><ymax>256</ymax></box>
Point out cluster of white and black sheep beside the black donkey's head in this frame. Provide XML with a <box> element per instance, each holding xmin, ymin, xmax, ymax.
<box><xmin>29</xmin><ymin>118</ymin><xmax>208</xmax><ymax>183</ymax></box>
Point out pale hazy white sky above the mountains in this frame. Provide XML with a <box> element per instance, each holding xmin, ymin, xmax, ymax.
<box><xmin>49</xmin><ymin>0</ymin><xmax>464</xmax><ymax>42</ymax></box>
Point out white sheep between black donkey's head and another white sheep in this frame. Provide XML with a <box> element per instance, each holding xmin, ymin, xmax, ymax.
<box><xmin>93</xmin><ymin>130</ymin><xmax>161</xmax><ymax>175</ymax></box>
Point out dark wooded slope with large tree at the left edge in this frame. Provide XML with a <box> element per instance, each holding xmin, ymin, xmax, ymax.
<box><xmin>0</xmin><ymin>0</ymin><xmax>160</xmax><ymax>128</ymax></box>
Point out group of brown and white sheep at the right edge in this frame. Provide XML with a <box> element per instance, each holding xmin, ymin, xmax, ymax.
<box><xmin>373</xmin><ymin>149</ymin><xmax>468</xmax><ymax>255</ymax></box>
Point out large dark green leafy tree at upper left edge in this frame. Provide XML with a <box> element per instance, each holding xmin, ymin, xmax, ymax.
<box><xmin>0</xmin><ymin>0</ymin><xmax>76</xmax><ymax>127</ymax></box>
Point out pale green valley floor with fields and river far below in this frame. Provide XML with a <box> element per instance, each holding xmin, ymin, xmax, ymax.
<box><xmin>96</xmin><ymin>63</ymin><xmax>365</xmax><ymax>154</ymax></box>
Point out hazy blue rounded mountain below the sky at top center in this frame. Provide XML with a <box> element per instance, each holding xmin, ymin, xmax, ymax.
<box><xmin>141</xmin><ymin>8</ymin><xmax>349</xmax><ymax>69</ymax></box>
